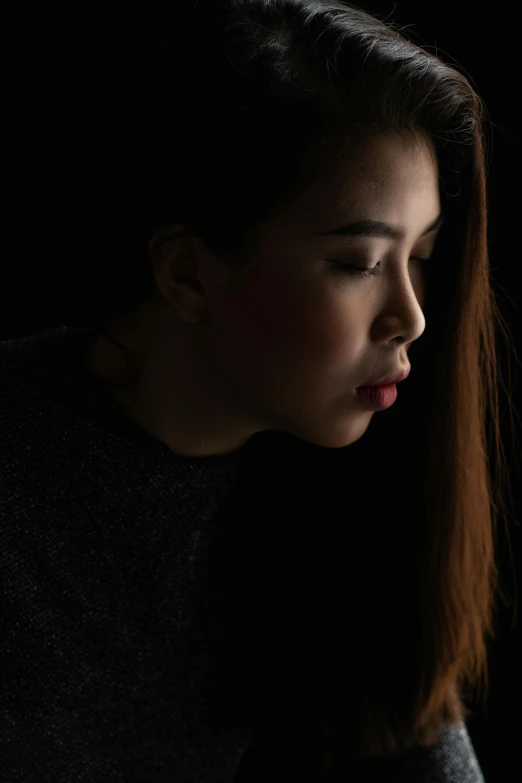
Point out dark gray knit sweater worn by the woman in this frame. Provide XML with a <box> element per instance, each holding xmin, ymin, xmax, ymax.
<box><xmin>0</xmin><ymin>326</ymin><xmax>483</xmax><ymax>783</ymax></box>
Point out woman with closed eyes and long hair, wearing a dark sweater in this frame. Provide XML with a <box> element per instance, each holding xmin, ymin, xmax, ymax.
<box><xmin>3</xmin><ymin>0</ymin><xmax>516</xmax><ymax>783</ymax></box>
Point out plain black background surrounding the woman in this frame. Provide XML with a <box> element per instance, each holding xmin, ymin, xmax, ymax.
<box><xmin>0</xmin><ymin>0</ymin><xmax>522</xmax><ymax>783</ymax></box>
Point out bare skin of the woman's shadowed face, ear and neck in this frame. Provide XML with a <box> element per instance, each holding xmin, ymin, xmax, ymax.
<box><xmin>84</xmin><ymin>135</ymin><xmax>440</xmax><ymax>457</ymax></box>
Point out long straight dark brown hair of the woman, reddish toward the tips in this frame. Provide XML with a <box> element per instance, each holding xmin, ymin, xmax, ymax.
<box><xmin>81</xmin><ymin>0</ymin><xmax>511</xmax><ymax>775</ymax></box>
